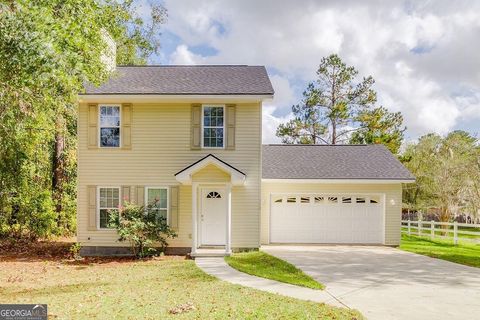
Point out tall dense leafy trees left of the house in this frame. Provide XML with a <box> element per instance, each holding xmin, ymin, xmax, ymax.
<box><xmin>0</xmin><ymin>0</ymin><xmax>167</xmax><ymax>236</ymax></box>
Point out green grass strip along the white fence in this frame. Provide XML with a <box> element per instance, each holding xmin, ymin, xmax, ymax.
<box><xmin>400</xmin><ymin>235</ymin><xmax>480</xmax><ymax>268</ymax></box>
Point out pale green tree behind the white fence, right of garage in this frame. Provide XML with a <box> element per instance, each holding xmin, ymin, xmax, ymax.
<box><xmin>401</xmin><ymin>131</ymin><xmax>480</xmax><ymax>221</ymax></box>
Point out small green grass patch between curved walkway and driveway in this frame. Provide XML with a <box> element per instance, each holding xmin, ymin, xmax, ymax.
<box><xmin>225</xmin><ymin>251</ymin><xmax>324</xmax><ymax>289</ymax></box>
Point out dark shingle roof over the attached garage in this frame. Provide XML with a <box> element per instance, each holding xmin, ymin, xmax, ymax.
<box><xmin>262</xmin><ymin>144</ymin><xmax>415</xmax><ymax>180</ymax></box>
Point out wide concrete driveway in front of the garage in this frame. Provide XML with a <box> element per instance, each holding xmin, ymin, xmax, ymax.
<box><xmin>262</xmin><ymin>246</ymin><xmax>480</xmax><ymax>320</ymax></box>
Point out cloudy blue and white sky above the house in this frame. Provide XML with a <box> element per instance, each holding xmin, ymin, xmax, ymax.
<box><xmin>138</xmin><ymin>0</ymin><xmax>480</xmax><ymax>143</ymax></box>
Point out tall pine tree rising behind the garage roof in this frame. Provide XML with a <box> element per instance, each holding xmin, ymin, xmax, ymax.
<box><xmin>277</xmin><ymin>54</ymin><xmax>404</xmax><ymax>152</ymax></box>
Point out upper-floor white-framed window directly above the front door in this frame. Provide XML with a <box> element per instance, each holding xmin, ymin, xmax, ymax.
<box><xmin>202</xmin><ymin>106</ymin><xmax>225</xmax><ymax>148</ymax></box>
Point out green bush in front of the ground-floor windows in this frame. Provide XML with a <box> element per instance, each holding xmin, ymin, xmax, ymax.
<box><xmin>109</xmin><ymin>203</ymin><xmax>177</xmax><ymax>258</ymax></box>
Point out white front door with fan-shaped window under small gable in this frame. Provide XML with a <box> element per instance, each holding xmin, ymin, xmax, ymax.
<box><xmin>200</xmin><ymin>187</ymin><xmax>228</xmax><ymax>246</ymax></box>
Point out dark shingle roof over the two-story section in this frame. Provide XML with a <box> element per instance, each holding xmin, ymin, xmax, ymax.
<box><xmin>85</xmin><ymin>65</ymin><xmax>273</xmax><ymax>95</ymax></box>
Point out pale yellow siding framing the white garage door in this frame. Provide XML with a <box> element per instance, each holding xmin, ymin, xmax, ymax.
<box><xmin>261</xmin><ymin>182</ymin><xmax>402</xmax><ymax>245</ymax></box>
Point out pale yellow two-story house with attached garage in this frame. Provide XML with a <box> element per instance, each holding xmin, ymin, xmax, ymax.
<box><xmin>77</xmin><ymin>65</ymin><xmax>414</xmax><ymax>255</ymax></box>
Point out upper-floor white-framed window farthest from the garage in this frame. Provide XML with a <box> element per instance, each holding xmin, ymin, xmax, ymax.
<box><xmin>99</xmin><ymin>105</ymin><xmax>120</xmax><ymax>148</ymax></box>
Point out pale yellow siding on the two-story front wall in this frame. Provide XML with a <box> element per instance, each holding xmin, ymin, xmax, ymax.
<box><xmin>77</xmin><ymin>101</ymin><xmax>261</xmax><ymax>247</ymax></box>
